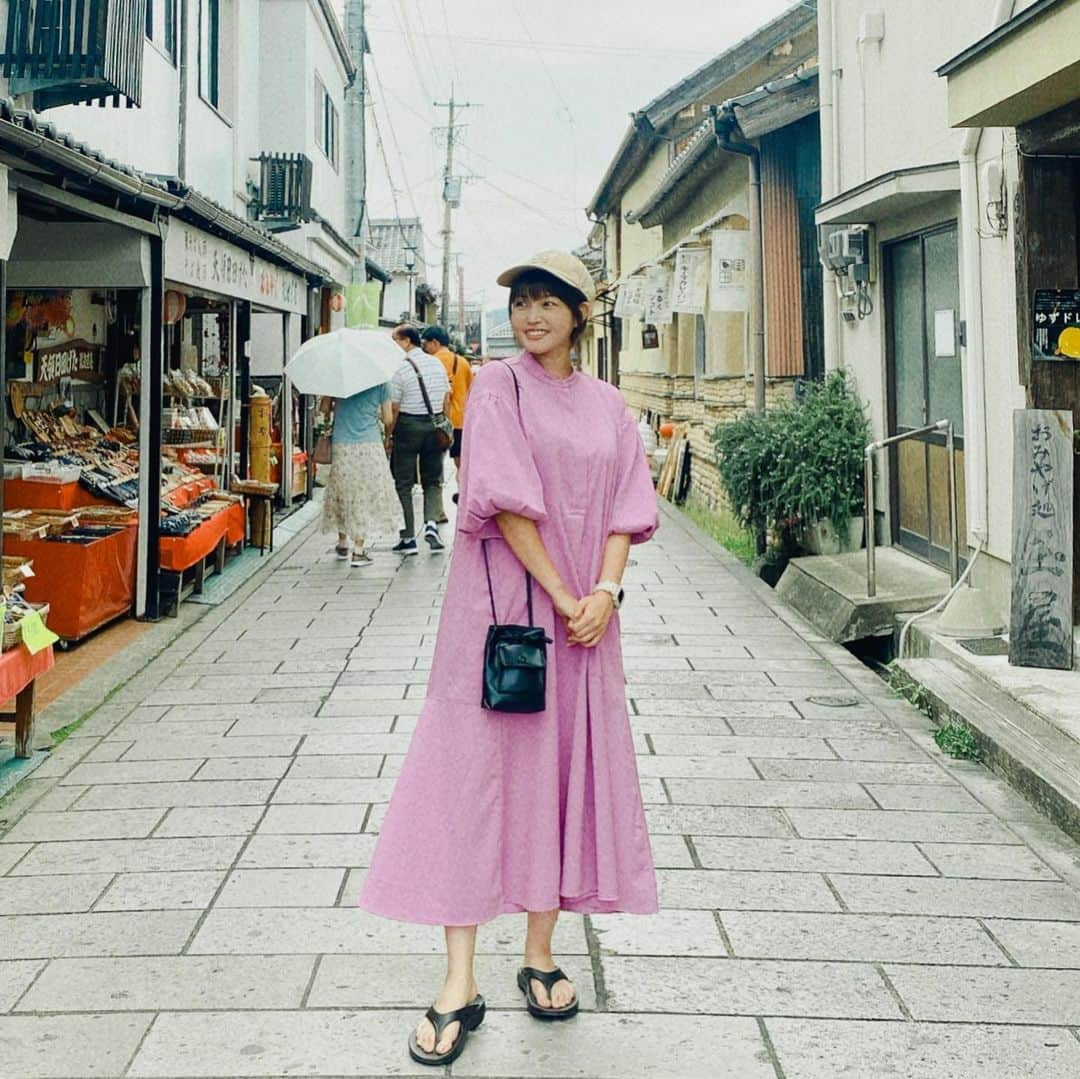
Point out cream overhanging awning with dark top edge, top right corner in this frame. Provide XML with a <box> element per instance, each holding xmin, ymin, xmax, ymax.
<box><xmin>937</xmin><ymin>0</ymin><xmax>1080</xmax><ymax>127</ymax></box>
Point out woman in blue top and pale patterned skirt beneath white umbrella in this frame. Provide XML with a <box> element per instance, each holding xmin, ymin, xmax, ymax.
<box><xmin>319</xmin><ymin>382</ymin><xmax>401</xmax><ymax>568</ymax></box>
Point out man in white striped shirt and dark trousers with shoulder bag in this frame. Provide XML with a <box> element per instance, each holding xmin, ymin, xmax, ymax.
<box><xmin>390</xmin><ymin>323</ymin><xmax>450</xmax><ymax>555</ymax></box>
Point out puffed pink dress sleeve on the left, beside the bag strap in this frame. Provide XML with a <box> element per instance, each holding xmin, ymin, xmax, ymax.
<box><xmin>458</xmin><ymin>379</ymin><xmax>548</xmax><ymax>539</ymax></box>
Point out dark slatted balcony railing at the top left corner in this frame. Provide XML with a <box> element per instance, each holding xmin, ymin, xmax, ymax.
<box><xmin>0</xmin><ymin>0</ymin><xmax>146</xmax><ymax>109</ymax></box>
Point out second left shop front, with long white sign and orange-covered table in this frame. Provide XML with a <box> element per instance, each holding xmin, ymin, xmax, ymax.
<box><xmin>161</xmin><ymin>218</ymin><xmax>311</xmax><ymax>585</ymax></box>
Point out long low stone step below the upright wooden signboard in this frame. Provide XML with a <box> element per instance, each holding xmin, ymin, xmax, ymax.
<box><xmin>896</xmin><ymin>659</ymin><xmax>1080</xmax><ymax>839</ymax></box>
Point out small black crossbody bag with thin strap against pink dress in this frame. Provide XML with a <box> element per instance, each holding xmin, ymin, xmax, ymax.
<box><xmin>481</xmin><ymin>367</ymin><xmax>552</xmax><ymax>713</ymax></box>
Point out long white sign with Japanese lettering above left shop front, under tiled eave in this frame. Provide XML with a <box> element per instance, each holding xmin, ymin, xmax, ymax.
<box><xmin>165</xmin><ymin>220</ymin><xmax>307</xmax><ymax>314</ymax></box>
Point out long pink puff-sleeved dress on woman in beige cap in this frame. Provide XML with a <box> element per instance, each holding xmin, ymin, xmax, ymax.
<box><xmin>360</xmin><ymin>352</ymin><xmax>658</xmax><ymax>926</ymax></box>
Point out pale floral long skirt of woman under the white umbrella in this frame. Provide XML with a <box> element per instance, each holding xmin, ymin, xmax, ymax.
<box><xmin>321</xmin><ymin>442</ymin><xmax>402</xmax><ymax>543</ymax></box>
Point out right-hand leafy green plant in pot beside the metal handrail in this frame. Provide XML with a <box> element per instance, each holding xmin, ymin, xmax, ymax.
<box><xmin>777</xmin><ymin>368</ymin><xmax>870</xmax><ymax>554</ymax></box>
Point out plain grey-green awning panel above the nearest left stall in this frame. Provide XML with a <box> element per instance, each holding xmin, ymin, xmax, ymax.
<box><xmin>8</xmin><ymin>217</ymin><xmax>150</xmax><ymax>288</ymax></box>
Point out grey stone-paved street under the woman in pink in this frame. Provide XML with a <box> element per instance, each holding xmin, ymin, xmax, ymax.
<box><xmin>0</xmin><ymin>512</ymin><xmax>1080</xmax><ymax>1079</ymax></box>
